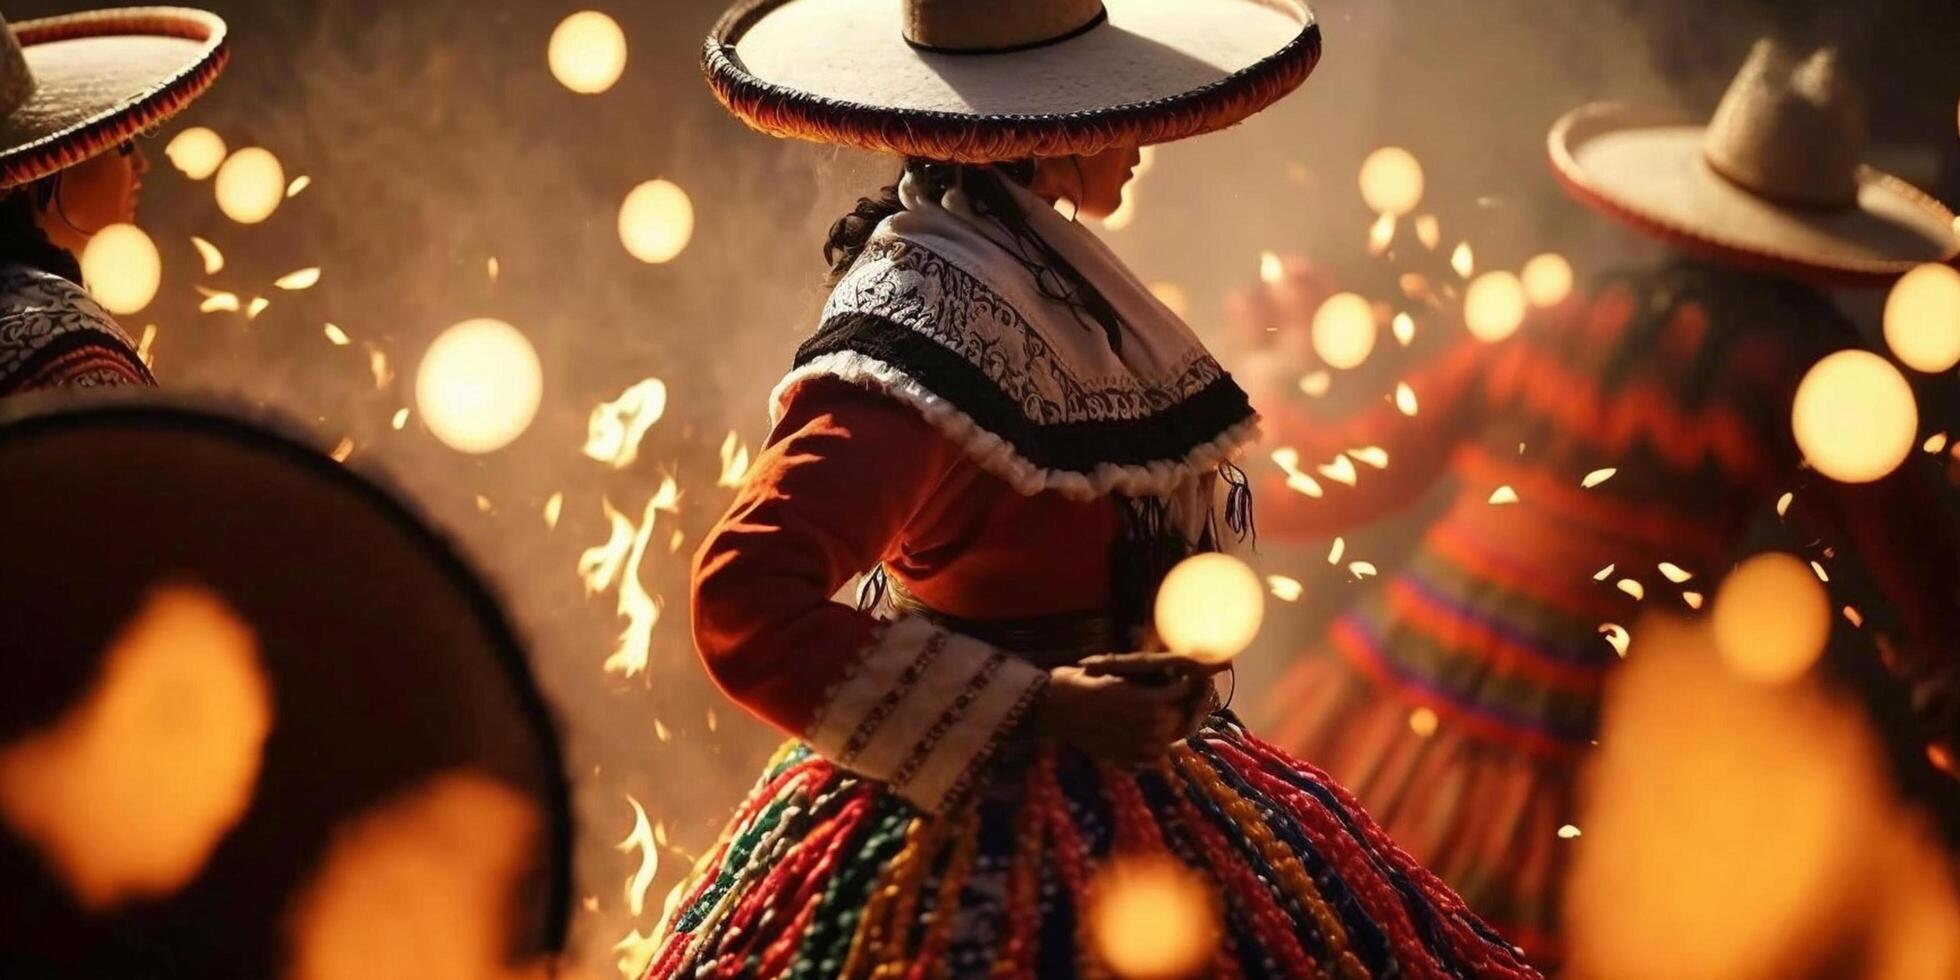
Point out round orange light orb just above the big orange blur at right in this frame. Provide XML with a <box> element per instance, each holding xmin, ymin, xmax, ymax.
<box><xmin>1713</xmin><ymin>551</ymin><xmax>1831</xmax><ymax>684</ymax></box>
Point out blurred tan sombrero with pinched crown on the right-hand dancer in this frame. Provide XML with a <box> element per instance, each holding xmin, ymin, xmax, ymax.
<box><xmin>1550</xmin><ymin>41</ymin><xmax>1960</xmax><ymax>284</ymax></box>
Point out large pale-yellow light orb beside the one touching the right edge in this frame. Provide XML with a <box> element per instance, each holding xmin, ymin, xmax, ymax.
<box><xmin>1789</xmin><ymin>351</ymin><xmax>1919</xmax><ymax>484</ymax></box>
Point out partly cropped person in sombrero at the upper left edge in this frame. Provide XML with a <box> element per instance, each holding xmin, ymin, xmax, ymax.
<box><xmin>0</xmin><ymin>8</ymin><xmax>229</xmax><ymax>396</ymax></box>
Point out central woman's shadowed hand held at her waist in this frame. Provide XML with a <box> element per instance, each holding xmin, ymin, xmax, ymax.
<box><xmin>1035</xmin><ymin>653</ymin><xmax>1217</xmax><ymax>766</ymax></box>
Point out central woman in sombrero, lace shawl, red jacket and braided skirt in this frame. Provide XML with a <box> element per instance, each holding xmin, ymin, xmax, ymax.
<box><xmin>651</xmin><ymin>0</ymin><xmax>1531</xmax><ymax>978</ymax></box>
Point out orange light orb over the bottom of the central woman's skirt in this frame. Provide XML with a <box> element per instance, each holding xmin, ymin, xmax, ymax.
<box><xmin>1088</xmin><ymin>855</ymin><xmax>1219</xmax><ymax>980</ymax></box>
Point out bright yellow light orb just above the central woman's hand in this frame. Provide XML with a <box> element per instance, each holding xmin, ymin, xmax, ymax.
<box><xmin>1156</xmin><ymin>551</ymin><xmax>1266</xmax><ymax>662</ymax></box>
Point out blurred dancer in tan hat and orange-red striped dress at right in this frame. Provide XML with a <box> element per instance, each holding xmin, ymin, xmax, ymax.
<box><xmin>1260</xmin><ymin>45</ymin><xmax>1960</xmax><ymax>964</ymax></box>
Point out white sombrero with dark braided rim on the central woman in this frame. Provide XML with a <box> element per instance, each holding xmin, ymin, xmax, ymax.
<box><xmin>704</xmin><ymin>0</ymin><xmax>1321</xmax><ymax>163</ymax></box>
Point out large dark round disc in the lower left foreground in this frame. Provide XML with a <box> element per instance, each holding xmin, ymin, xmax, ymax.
<box><xmin>0</xmin><ymin>390</ymin><xmax>572</xmax><ymax>976</ymax></box>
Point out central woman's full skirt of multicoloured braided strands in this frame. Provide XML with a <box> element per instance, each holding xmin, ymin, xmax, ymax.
<box><xmin>647</xmin><ymin>715</ymin><xmax>1537</xmax><ymax>978</ymax></box>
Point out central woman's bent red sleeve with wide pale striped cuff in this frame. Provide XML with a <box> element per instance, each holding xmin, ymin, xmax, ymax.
<box><xmin>694</xmin><ymin>378</ymin><xmax>1047</xmax><ymax>809</ymax></box>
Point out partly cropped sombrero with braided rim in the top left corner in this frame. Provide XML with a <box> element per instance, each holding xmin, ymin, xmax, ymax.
<box><xmin>0</xmin><ymin>6</ymin><xmax>227</xmax><ymax>188</ymax></box>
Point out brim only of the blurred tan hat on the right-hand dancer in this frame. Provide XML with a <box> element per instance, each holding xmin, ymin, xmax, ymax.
<box><xmin>1548</xmin><ymin>104</ymin><xmax>1960</xmax><ymax>286</ymax></box>
